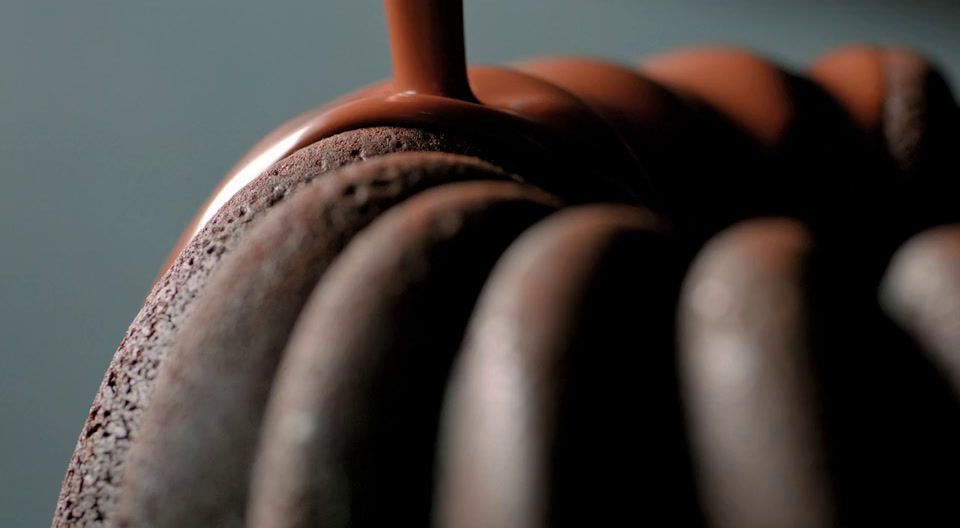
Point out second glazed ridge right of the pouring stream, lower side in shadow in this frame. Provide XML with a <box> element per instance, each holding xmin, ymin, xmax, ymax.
<box><xmin>517</xmin><ymin>57</ymin><xmax>770</xmax><ymax>241</ymax></box>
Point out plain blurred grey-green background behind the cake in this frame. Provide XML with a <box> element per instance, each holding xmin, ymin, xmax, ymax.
<box><xmin>0</xmin><ymin>0</ymin><xmax>960</xmax><ymax>527</ymax></box>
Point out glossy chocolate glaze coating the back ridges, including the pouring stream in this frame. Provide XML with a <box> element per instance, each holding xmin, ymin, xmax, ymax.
<box><xmin>165</xmin><ymin>0</ymin><xmax>960</xmax><ymax>268</ymax></box>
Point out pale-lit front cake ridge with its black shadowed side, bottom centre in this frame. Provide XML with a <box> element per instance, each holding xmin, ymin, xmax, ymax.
<box><xmin>434</xmin><ymin>205</ymin><xmax>698</xmax><ymax>527</ymax></box>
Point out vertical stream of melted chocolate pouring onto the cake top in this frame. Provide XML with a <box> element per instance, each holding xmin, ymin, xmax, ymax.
<box><xmin>383</xmin><ymin>0</ymin><xmax>477</xmax><ymax>102</ymax></box>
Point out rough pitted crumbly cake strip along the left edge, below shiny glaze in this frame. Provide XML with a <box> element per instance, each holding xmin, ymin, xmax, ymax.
<box><xmin>53</xmin><ymin>127</ymin><xmax>510</xmax><ymax>527</ymax></box>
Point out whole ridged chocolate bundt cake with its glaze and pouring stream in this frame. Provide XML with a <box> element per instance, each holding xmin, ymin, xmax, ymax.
<box><xmin>53</xmin><ymin>0</ymin><xmax>960</xmax><ymax>528</ymax></box>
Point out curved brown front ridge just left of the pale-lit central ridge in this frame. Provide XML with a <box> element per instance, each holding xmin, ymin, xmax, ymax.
<box><xmin>250</xmin><ymin>182</ymin><xmax>557</xmax><ymax>527</ymax></box>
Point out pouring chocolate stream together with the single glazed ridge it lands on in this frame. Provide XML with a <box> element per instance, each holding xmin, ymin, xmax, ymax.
<box><xmin>181</xmin><ymin>0</ymin><xmax>651</xmax><ymax>250</ymax></box>
